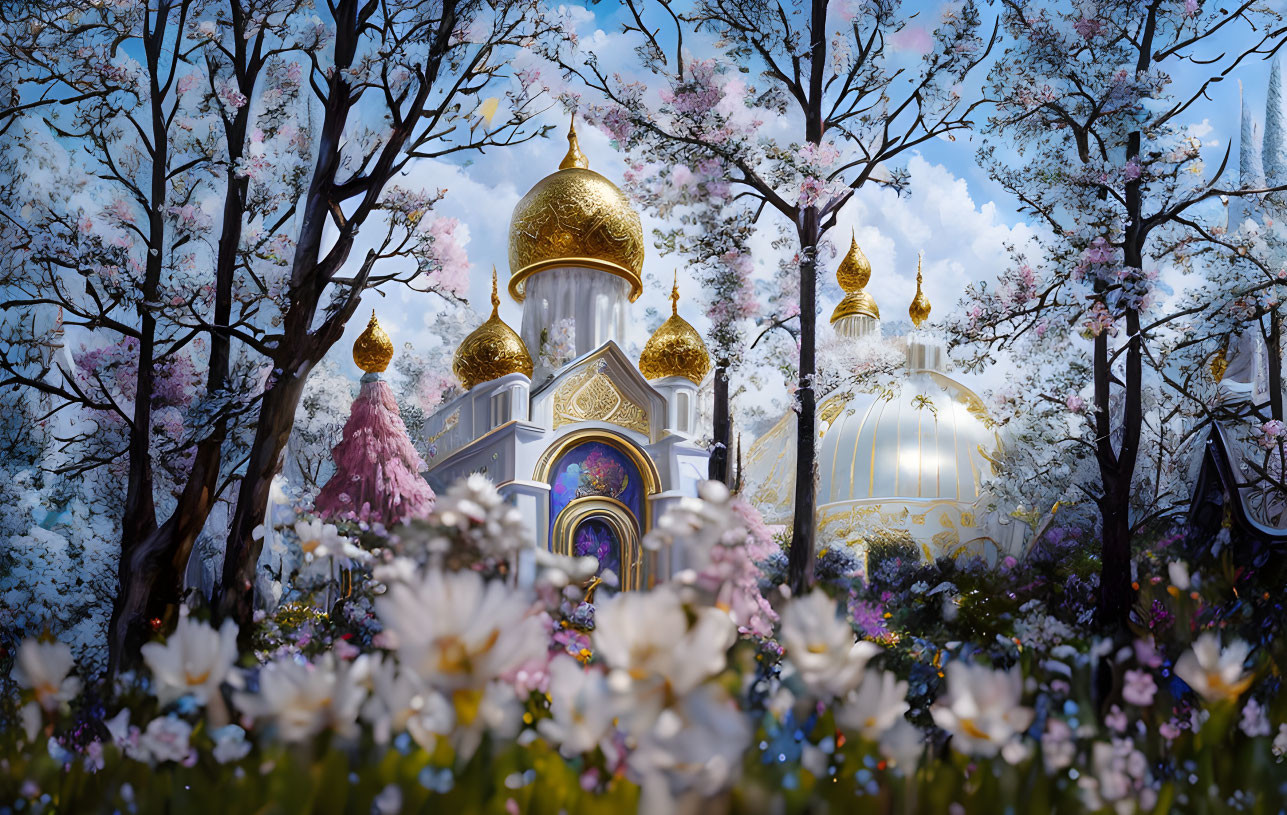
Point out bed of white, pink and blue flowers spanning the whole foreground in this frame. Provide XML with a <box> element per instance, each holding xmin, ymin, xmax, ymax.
<box><xmin>0</xmin><ymin>478</ymin><xmax>1287</xmax><ymax>812</ymax></box>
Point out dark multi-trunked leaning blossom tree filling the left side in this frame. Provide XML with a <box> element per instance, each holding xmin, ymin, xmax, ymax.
<box><xmin>0</xmin><ymin>0</ymin><xmax>544</xmax><ymax>667</ymax></box>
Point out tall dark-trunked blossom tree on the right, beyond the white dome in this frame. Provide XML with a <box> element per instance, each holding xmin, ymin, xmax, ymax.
<box><xmin>956</xmin><ymin>0</ymin><xmax>1283</xmax><ymax>624</ymax></box>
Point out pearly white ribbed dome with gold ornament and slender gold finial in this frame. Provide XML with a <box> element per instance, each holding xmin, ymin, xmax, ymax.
<box><xmin>745</xmin><ymin>263</ymin><xmax>1022</xmax><ymax>560</ymax></box>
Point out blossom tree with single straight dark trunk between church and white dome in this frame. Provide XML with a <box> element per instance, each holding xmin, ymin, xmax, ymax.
<box><xmin>559</xmin><ymin>0</ymin><xmax>996</xmax><ymax>590</ymax></box>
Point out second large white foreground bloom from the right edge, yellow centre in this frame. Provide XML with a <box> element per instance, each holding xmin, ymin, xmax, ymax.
<box><xmin>931</xmin><ymin>662</ymin><xmax>1032</xmax><ymax>757</ymax></box>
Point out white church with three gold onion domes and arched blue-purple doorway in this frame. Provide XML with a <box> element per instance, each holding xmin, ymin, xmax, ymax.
<box><xmin>425</xmin><ymin>121</ymin><xmax>710</xmax><ymax>590</ymax></box>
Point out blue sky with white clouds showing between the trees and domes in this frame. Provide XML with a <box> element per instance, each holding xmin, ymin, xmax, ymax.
<box><xmin>316</xmin><ymin>3</ymin><xmax>1269</xmax><ymax>396</ymax></box>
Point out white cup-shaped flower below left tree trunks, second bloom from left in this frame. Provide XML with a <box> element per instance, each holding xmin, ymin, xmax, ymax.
<box><xmin>142</xmin><ymin>615</ymin><xmax>237</xmax><ymax>704</ymax></box>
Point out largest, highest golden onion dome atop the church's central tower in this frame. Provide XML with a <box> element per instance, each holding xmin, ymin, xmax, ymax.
<box><xmin>510</xmin><ymin>115</ymin><xmax>644</xmax><ymax>303</ymax></box>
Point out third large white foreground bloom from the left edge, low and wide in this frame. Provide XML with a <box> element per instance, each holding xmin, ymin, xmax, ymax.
<box><xmin>237</xmin><ymin>655</ymin><xmax>366</xmax><ymax>742</ymax></box>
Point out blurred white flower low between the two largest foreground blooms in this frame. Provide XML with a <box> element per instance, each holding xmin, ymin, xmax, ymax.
<box><xmin>537</xmin><ymin>655</ymin><xmax>614</xmax><ymax>758</ymax></box>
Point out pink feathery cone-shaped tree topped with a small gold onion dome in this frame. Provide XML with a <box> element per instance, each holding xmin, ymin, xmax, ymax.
<box><xmin>315</xmin><ymin>313</ymin><xmax>434</xmax><ymax>527</ymax></box>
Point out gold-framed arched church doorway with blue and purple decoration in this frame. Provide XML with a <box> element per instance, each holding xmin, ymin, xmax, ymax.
<box><xmin>535</xmin><ymin>430</ymin><xmax>659</xmax><ymax>590</ymax></box>
